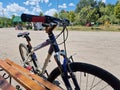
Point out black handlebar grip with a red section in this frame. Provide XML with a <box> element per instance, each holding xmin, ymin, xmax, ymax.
<box><xmin>21</xmin><ymin>14</ymin><xmax>46</xmax><ymax>23</ymax></box>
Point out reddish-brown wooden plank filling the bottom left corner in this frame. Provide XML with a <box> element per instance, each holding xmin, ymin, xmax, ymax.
<box><xmin>0</xmin><ymin>75</ymin><xmax>16</xmax><ymax>90</ymax></box>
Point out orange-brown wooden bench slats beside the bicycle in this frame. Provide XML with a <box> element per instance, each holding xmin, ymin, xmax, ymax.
<box><xmin>0</xmin><ymin>59</ymin><xmax>61</xmax><ymax>90</ymax></box>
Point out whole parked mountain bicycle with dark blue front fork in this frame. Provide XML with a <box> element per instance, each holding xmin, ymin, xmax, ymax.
<box><xmin>17</xmin><ymin>14</ymin><xmax>120</xmax><ymax>90</ymax></box>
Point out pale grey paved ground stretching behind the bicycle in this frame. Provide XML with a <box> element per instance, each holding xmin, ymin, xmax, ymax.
<box><xmin>0</xmin><ymin>29</ymin><xmax>120</xmax><ymax>87</ymax></box>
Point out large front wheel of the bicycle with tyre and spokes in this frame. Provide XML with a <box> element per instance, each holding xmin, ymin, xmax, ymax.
<box><xmin>48</xmin><ymin>62</ymin><xmax>120</xmax><ymax>90</ymax></box>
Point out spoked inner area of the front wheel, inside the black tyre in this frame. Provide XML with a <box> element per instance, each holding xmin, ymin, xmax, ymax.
<box><xmin>54</xmin><ymin>72</ymin><xmax>114</xmax><ymax>90</ymax></box>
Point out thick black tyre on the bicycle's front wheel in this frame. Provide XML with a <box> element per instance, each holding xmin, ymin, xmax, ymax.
<box><xmin>48</xmin><ymin>62</ymin><xmax>120</xmax><ymax>90</ymax></box>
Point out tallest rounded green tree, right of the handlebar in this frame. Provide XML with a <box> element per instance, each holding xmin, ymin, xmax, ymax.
<box><xmin>75</xmin><ymin>0</ymin><xmax>106</xmax><ymax>24</ymax></box>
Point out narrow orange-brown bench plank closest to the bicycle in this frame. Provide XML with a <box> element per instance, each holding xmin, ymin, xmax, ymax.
<box><xmin>5</xmin><ymin>59</ymin><xmax>62</xmax><ymax>90</ymax></box>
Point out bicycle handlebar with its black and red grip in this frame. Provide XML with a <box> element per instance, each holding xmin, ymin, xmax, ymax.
<box><xmin>21</xmin><ymin>14</ymin><xmax>70</xmax><ymax>25</ymax></box>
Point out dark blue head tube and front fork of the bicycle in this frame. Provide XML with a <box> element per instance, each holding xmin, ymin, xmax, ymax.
<box><xmin>47</xmin><ymin>24</ymin><xmax>80</xmax><ymax>90</ymax></box>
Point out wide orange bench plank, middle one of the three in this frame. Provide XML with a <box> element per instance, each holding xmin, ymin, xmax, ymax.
<box><xmin>0</xmin><ymin>60</ymin><xmax>45</xmax><ymax>90</ymax></box>
